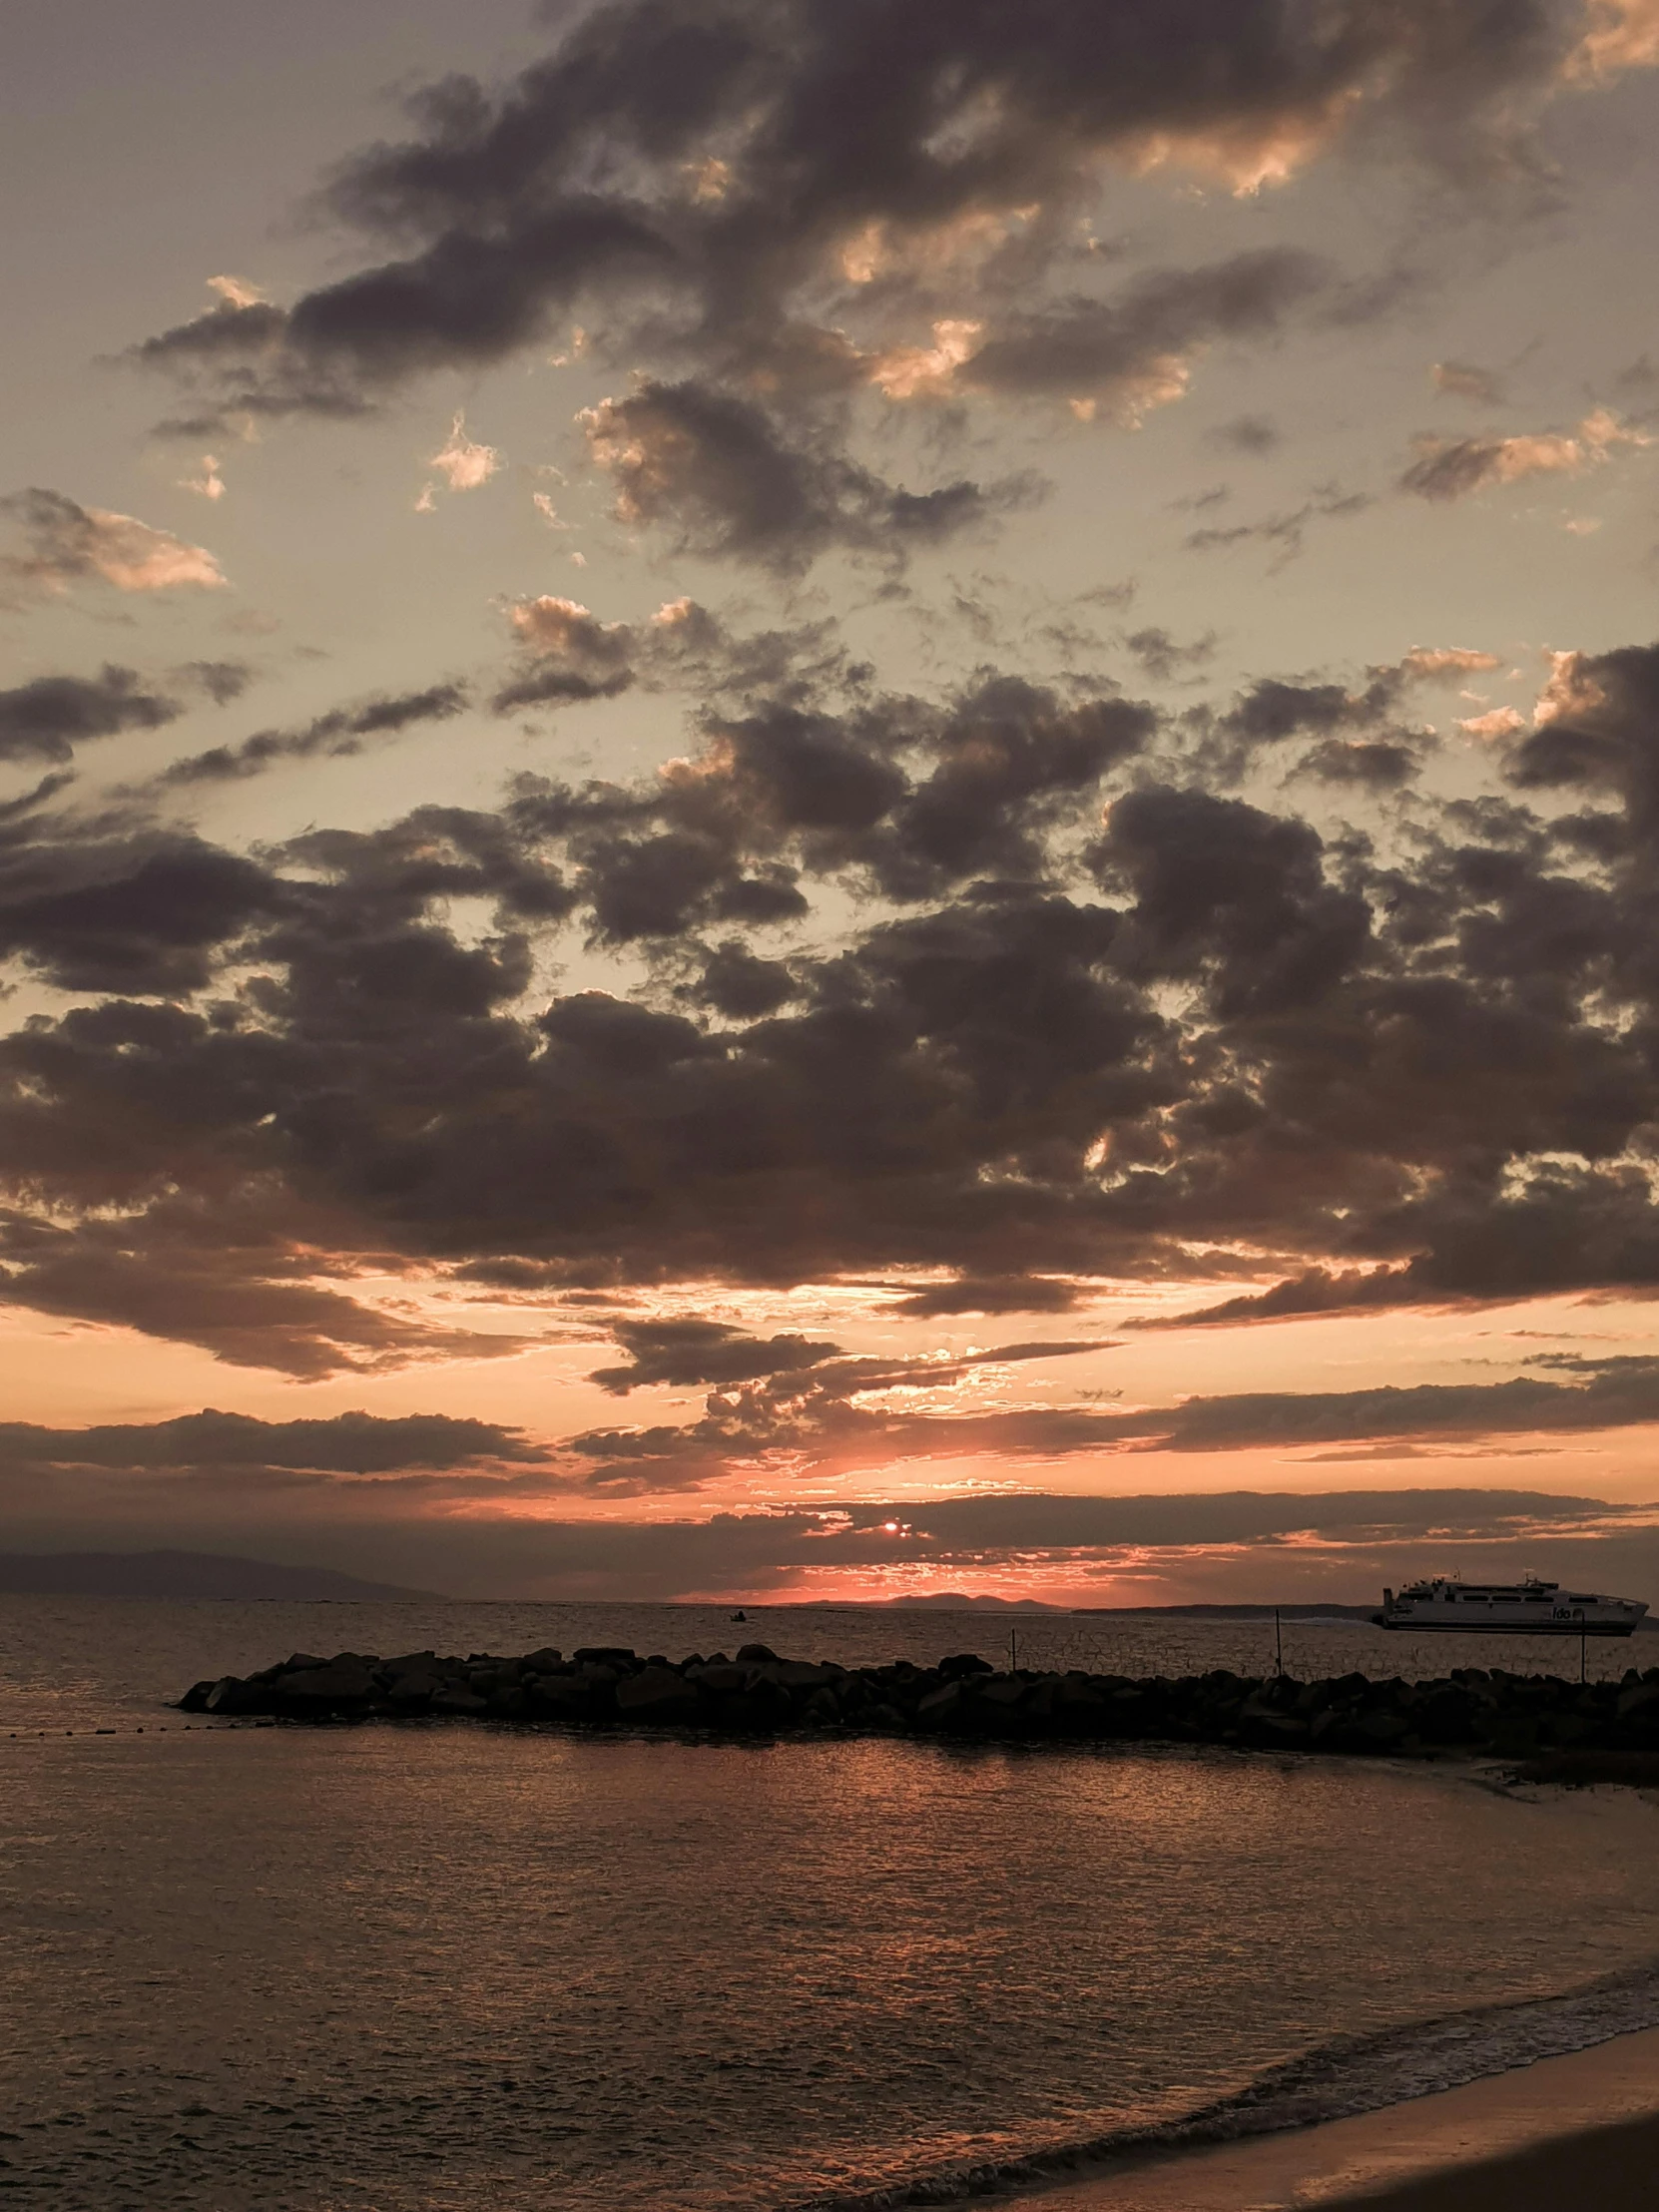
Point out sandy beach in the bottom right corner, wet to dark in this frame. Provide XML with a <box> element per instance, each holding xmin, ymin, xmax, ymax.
<box><xmin>1022</xmin><ymin>2028</ymin><xmax>1659</xmax><ymax>2212</ymax></box>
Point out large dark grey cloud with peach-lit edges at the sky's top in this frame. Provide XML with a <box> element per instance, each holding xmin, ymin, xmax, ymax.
<box><xmin>137</xmin><ymin>0</ymin><xmax>1648</xmax><ymax>446</ymax></box>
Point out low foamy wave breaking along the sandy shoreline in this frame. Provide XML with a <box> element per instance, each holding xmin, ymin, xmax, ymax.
<box><xmin>790</xmin><ymin>1959</ymin><xmax>1659</xmax><ymax>2212</ymax></box>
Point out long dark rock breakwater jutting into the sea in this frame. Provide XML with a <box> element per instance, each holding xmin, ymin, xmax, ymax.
<box><xmin>179</xmin><ymin>1643</ymin><xmax>1659</xmax><ymax>1761</ymax></box>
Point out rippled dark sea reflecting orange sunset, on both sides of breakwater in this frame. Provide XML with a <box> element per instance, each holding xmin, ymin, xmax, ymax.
<box><xmin>0</xmin><ymin>1597</ymin><xmax>1659</xmax><ymax>2212</ymax></box>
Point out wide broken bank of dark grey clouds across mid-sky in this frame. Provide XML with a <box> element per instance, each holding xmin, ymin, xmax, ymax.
<box><xmin>0</xmin><ymin>623</ymin><xmax>1659</xmax><ymax>1371</ymax></box>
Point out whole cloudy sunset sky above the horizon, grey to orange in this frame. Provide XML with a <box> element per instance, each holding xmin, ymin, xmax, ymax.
<box><xmin>0</xmin><ymin>0</ymin><xmax>1659</xmax><ymax>1606</ymax></box>
